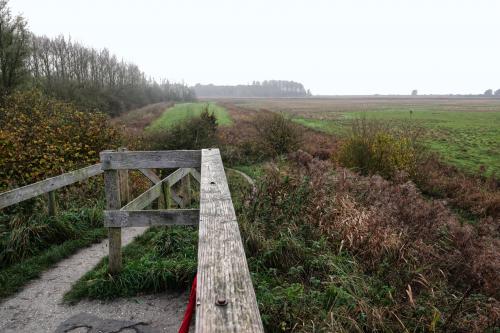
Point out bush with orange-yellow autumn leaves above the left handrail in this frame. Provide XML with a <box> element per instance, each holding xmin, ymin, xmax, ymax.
<box><xmin>0</xmin><ymin>90</ymin><xmax>119</xmax><ymax>191</ymax></box>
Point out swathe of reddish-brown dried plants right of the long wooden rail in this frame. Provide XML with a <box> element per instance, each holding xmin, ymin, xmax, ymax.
<box><xmin>289</xmin><ymin>153</ymin><xmax>500</xmax><ymax>299</ymax></box>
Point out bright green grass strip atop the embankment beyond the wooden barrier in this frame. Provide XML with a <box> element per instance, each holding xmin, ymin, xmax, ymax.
<box><xmin>146</xmin><ymin>102</ymin><xmax>232</xmax><ymax>131</ymax></box>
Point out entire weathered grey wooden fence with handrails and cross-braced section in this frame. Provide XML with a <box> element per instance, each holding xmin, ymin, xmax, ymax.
<box><xmin>0</xmin><ymin>148</ymin><xmax>264</xmax><ymax>332</ymax></box>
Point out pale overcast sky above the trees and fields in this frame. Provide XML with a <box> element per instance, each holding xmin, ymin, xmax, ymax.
<box><xmin>6</xmin><ymin>0</ymin><xmax>500</xmax><ymax>94</ymax></box>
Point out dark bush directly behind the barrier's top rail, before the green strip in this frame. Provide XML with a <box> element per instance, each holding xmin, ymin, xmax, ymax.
<box><xmin>144</xmin><ymin>106</ymin><xmax>218</xmax><ymax>150</ymax></box>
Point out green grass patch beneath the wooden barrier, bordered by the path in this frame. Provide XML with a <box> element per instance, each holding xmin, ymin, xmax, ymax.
<box><xmin>64</xmin><ymin>227</ymin><xmax>198</xmax><ymax>303</ymax></box>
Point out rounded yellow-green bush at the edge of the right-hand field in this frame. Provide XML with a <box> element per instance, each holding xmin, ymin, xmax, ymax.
<box><xmin>337</xmin><ymin>119</ymin><xmax>422</xmax><ymax>178</ymax></box>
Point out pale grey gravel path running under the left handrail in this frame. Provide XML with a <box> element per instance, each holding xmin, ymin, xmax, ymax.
<box><xmin>0</xmin><ymin>228</ymin><xmax>188</xmax><ymax>333</ymax></box>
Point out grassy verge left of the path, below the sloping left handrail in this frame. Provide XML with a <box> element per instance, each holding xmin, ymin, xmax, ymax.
<box><xmin>0</xmin><ymin>204</ymin><xmax>107</xmax><ymax>298</ymax></box>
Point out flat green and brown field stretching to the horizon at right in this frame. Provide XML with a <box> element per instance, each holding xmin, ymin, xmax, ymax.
<box><xmin>231</xmin><ymin>97</ymin><xmax>500</xmax><ymax>175</ymax></box>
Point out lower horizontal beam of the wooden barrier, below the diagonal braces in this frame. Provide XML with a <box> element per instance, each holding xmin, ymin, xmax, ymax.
<box><xmin>104</xmin><ymin>209</ymin><xmax>200</xmax><ymax>228</ymax></box>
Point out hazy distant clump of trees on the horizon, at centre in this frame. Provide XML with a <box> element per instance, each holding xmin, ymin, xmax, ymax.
<box><xmin>193</xmin><ymin>80</ymin><xmax>311</xmax><ymax>97</ymax></box>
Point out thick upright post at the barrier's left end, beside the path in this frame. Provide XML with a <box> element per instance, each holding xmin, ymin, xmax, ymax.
<box><xmin>104</xmin><ymin>164</ymin><xmax>122</xmax><ymax>274</ymax></box>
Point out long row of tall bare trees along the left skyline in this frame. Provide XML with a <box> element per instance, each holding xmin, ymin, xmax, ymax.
<box><xmin>0</xmin><ymin>0</ymin><xmax>195</xmax><ymax>116</ymax></box>
